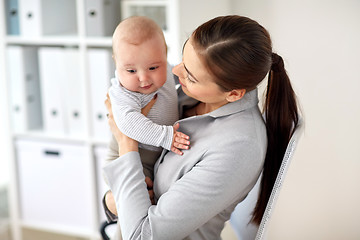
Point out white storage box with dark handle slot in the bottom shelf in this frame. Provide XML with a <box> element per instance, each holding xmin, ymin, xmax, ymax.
<box><xmin>15</xmin><ymin>139</ymin><xmax>95</xmax><ymax>232</ymax></box>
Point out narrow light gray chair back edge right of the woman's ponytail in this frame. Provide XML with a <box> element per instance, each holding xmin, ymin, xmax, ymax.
<box><xmin>255</xmin><ymin>118</ymin><xmax>304</xmax><ymax>240</ymax></box>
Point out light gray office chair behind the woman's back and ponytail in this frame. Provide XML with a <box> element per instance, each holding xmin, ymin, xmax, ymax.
<box><xmin>230</xmin><ymin>118</ymin><xmax>303</xmax><ymax>240</ymax></box>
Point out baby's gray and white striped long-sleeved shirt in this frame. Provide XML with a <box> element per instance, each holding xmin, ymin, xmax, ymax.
<box><xmin>109</xmin><ymin>65</ymin><xmax>179</xmax><ymax>151</ymax></box>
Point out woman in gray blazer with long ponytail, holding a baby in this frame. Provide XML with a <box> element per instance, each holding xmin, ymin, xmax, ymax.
<box><xmin>104</xmin><ymin>16</ymin><xmax>298</xmax><ymax>240</ymax></box>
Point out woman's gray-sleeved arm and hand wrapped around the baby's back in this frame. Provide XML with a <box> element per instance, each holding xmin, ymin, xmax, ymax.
<box><xmin>104</xmin><ymin>94</ymin><xmax>261</xmax><ymax>240</ymax></box>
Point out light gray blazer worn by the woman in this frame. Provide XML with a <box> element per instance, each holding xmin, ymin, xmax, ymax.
<box><xmin>104</xmin><ymin>90</ymin><xmax>267</xmax><ymax>240</ymax></box>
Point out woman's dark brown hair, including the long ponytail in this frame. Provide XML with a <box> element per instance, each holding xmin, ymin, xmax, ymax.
<box><xmin>191</xmin><ymin>15</ymin><xmax>299</xmax><ymax>224</ymax></box>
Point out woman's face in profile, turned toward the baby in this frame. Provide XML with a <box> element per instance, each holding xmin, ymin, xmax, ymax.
<box><xmin>172</xmin><ymin>38</ymin><xmax>228</xmax><ymax>107</ymax></box>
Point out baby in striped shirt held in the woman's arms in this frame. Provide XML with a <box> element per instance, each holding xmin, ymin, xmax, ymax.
<box><xmin>105</xmin><ymin>17</ymin><xmax>190</xmax><ymax>223</ymax></box>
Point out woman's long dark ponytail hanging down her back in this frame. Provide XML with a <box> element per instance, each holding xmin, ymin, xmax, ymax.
<box><xmin>252</xmin><ymin>53</ymin><xmax>299</xmax><ymax>224</ymax></box>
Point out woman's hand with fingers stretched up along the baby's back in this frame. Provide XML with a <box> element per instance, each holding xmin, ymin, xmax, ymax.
<box><xmin>105</xmin><ymin>94</ymin><xmax>139</xmax><ymax>156</ymax></box>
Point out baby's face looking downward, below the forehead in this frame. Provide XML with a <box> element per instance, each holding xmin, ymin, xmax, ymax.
<box><xmin>114</xmin><ymin>36</ymin><xmax>167</xmax><ymax>94</ymax></box>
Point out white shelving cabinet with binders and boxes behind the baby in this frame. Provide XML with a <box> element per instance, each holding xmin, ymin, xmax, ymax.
<box><xmin>0</xmin><ymin>0</ymin><xmax>230</xmax><ymax>240</ymax></box>
